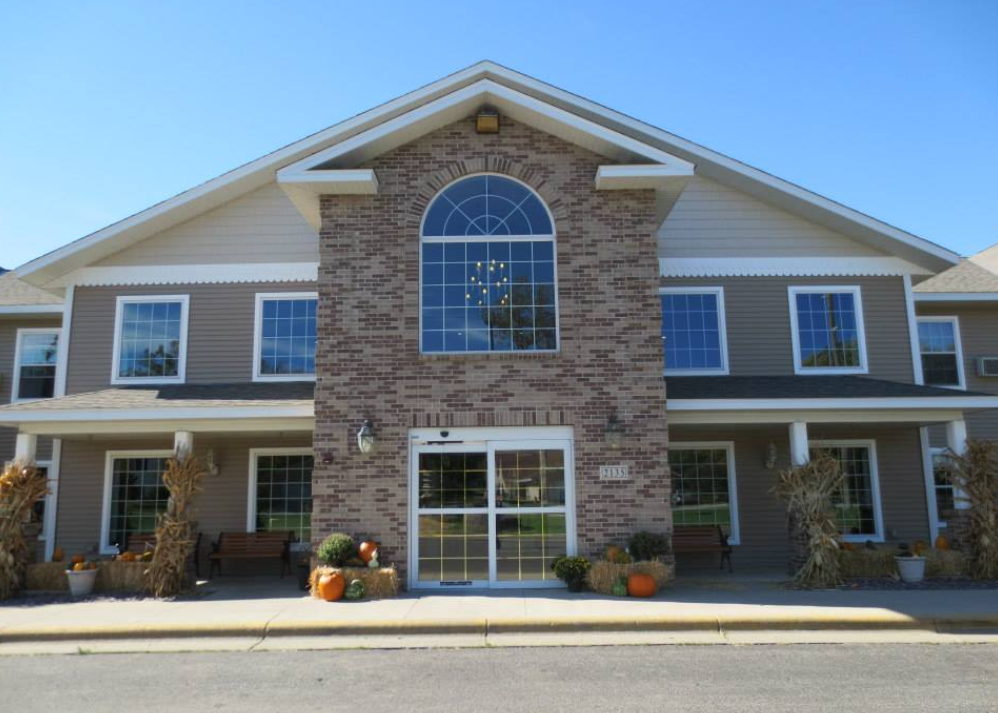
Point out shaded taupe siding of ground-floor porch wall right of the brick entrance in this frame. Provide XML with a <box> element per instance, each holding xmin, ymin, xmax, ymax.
<box><xmin>669</xmin><ymin>424</ymin><xmax>929</xmax><ymax>576</ymax></box>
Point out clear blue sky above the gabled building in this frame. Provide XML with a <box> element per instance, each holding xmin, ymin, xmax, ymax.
<box><xmin>0</xmin><ymin>0</ymin><xmax>998</xmax><ymax>267</ymax></box>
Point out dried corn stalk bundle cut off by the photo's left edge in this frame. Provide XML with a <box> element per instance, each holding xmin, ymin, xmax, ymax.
<box><xmin>0</xmin><ymin>461</ymin><xmax>48</xmax><ymax>599</ymax></box>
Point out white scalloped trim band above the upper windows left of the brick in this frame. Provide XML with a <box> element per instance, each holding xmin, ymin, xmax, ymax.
<box><xmin>54</xmin><ymin>262</ymin><xmax>319</xmax><ymax>286</ymax></box>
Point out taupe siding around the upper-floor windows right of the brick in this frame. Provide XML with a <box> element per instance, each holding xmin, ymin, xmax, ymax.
<box><xmin>662</xmin><ymin>276</ymin><xmax>914</xmax><ymax>383</ymax></box>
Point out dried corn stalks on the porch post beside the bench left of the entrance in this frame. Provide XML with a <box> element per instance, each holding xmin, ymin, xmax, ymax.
<box><xmin>145</xmin><ymin>455</ymin><xmax>205</xmax><ymax>597</ymax></box>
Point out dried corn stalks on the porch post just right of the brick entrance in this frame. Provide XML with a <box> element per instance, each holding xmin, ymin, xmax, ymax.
<box><xmin>774</xmin><ymin>451</ymin><xmax>844</xmax><ymax>587</ymax></box>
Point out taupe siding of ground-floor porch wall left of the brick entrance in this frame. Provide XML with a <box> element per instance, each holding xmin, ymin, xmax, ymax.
<box><xmin>56</xmin><ymin>434</ymin><xmax>312</xmax><ymax>560</ymax></box>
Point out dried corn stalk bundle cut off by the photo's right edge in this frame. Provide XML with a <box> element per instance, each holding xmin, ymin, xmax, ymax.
<box><xmin>946</xmin><ymin>439</ymin><xmax>998</xmax><ymax>579</ymax></box>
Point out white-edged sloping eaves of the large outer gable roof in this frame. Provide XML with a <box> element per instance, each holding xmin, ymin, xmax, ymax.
<box><xmin>18</xmin><ymin>61</ymin><xmax>958</xmax><ymax>285</ymax></box>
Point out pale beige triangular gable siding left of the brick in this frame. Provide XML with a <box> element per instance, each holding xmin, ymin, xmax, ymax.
<box><xmin>95</xmin><ymin>183</ymin><xmax>319</xmax><ymax>266</ymax></box>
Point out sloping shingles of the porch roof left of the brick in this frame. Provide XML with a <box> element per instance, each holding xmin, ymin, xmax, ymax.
<box><xmin>0</xmin><ymin>381</ymin><xmax>315</xmax><ymax>413</ymax></box>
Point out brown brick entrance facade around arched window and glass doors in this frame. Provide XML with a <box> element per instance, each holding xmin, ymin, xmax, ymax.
<box><xmin>312</xmin><ymin>117</ymin><xmax>671</xmax><ymax>580</ymax></box>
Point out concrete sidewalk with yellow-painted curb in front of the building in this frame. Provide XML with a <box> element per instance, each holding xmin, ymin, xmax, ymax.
<box><xmin>0</xmin><ymin>579</ymin><xmax>998</xmax><ymax>644</ymax></box>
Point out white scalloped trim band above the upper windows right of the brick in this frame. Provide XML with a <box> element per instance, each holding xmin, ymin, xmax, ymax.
<box><xmin>658</xmin><ymin>256</ymin><xmax>927</xmax><ymax>277</ymax></box>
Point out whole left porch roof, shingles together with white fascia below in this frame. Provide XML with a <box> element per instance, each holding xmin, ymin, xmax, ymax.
<box><xmin>0</xmin><ymin>382</ymin><xmax>315</xmax><ymax>435</ymax></box>
